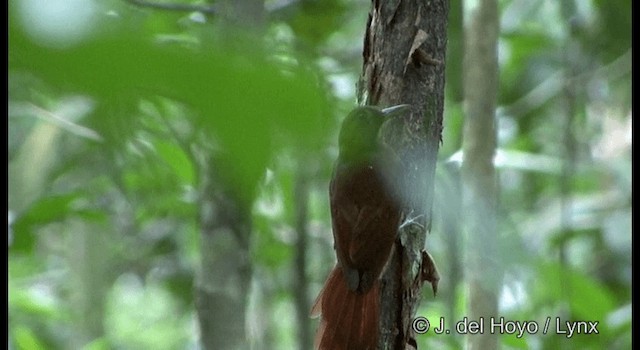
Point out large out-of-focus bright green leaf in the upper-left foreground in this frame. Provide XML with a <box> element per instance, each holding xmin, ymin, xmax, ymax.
<box><xmin>10</xmin><ymin>17</ymin><xmax>327</xmax><ymax>202</ymax></box>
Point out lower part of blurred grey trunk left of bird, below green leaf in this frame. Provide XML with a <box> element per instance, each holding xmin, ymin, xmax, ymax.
<box><xmin>196</xmin><ymin>156</ymin><xmax>251</xmax><ymax>349</ymax></box>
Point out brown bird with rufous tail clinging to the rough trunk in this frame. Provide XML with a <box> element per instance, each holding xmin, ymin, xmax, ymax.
<box><xmin>311</xmin><ymin>105</ymin><xmax>410</xmax><ymax>350</ymax></box>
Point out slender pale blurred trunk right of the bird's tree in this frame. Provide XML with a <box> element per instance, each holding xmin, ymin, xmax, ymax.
<box><xmin>462</xmin><ymin>0</ymin><xmax>502</xmax><ymax>349</ymax></box>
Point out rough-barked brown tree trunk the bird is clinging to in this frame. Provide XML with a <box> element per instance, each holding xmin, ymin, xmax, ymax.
<box><xmin>358</xmin><ymin>0</ymin><xmax>449</xmax><ymax>349</ymax></box>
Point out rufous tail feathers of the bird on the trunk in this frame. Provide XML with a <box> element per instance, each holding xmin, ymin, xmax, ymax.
<box><xmin>311</xmin><ymin>266</ymin><xmax>380</xmax><ymax>350</ymax></box>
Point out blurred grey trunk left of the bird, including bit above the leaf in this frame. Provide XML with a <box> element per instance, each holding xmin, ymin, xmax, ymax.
<box><xmin>196</xmin><ymin>0</ymin><xmax>264</xmax><ymax>350</ymax></box>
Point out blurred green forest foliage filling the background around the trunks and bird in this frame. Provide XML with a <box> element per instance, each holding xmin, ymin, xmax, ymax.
<box><xmin>8</xmin><ymin>0</ymin><xmax>631</xmax><ymax>349</ymax></box>
